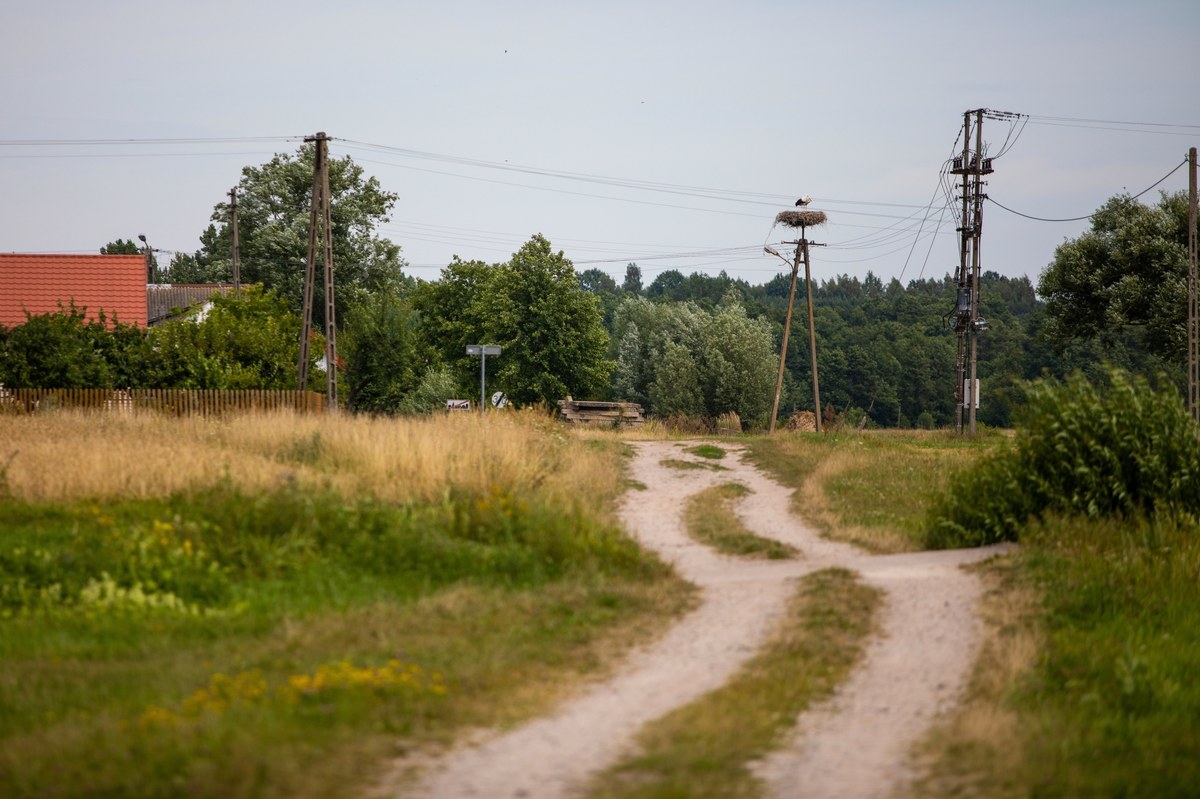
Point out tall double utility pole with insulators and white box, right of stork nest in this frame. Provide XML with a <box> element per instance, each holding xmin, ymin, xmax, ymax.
<box><xmin>950</xmin><ymin>108</ymin><xmax>992</xmax><ymax>438</ymax></box>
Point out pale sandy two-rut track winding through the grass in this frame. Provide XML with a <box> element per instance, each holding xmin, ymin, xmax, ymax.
<box><xmin>388</xmin><ymin>441</ymin><xmax>996</xmax><ymax>799</ymax></box>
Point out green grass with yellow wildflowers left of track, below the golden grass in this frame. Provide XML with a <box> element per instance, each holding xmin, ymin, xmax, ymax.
<box><xmin>0</xmin><ymin>486</ymin><xmax>690</xmax><ymax>798</ymax></box>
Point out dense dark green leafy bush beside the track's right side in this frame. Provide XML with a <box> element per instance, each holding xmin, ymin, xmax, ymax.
<box><xmin>925</xmin><ymin>368</ymin><xmax>1200</xmax><ymax>548</ymax></box>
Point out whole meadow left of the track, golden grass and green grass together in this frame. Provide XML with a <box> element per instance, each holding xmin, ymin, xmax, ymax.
<box><xmin>0</xmin><ymin>414</ymin><xmax>689</xmax><ymax>797</ymax></box>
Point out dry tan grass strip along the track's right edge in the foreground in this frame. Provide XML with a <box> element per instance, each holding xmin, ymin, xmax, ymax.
<box><xmin>911</xmin><ymin>559</ymin><xmax>1044</xmax><ymax>799</ymax></box>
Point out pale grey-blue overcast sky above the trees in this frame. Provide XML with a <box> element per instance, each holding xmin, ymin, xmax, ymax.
<box><xmin>0</xmin><ymin>0</ymin><xmax>1200</xmax><ymax>284</ymax></box>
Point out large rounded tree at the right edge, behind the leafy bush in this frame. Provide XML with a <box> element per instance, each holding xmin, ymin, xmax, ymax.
<box><xmin>1038</xmin><ymin>192</ymin><xmax>1187</xmax><ymax>361</ymax></box>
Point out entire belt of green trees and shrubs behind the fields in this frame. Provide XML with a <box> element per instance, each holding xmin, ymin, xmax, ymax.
<box><xmin>0</xmin><ymin>144</ymin><xmax>1187</xmax><ymax>427</ymax></box>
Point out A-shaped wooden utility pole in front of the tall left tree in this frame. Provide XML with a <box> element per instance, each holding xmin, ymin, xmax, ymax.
<box><xmin>299</xmin><ymin>131</ymin><xmax>337</xmax><ymax>410</ymax></box>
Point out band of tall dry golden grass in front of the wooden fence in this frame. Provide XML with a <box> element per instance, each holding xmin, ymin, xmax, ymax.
<box><xmin>0</xmin><ymin>413</ymin><xmax>620</xmax><ymax>506</ymax></box>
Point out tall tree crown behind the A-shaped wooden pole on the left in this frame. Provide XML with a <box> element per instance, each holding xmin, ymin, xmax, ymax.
<box><xmin>178</xmin><ymin>143</ymin><xmax>408</xmax><ymax>325</ymax></box>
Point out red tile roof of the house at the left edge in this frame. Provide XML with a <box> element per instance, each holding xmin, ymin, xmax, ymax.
<box><xmin>0</xmin><ymin>253</ymin><xmax>146</xmax><ymax>328</ymax></box>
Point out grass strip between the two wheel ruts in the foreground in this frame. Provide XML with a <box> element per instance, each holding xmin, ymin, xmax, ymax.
<box><xmin>587</xmin><ymin>569</ymin><xmax>881</xmax><ymax>799</ymax></box>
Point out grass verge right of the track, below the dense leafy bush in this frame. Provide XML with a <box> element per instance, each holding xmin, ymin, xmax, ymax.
<box><xmin>914</xmin><ymin>517</ymin><xmax>1200</xmax><ymax>799</ymax></box>
